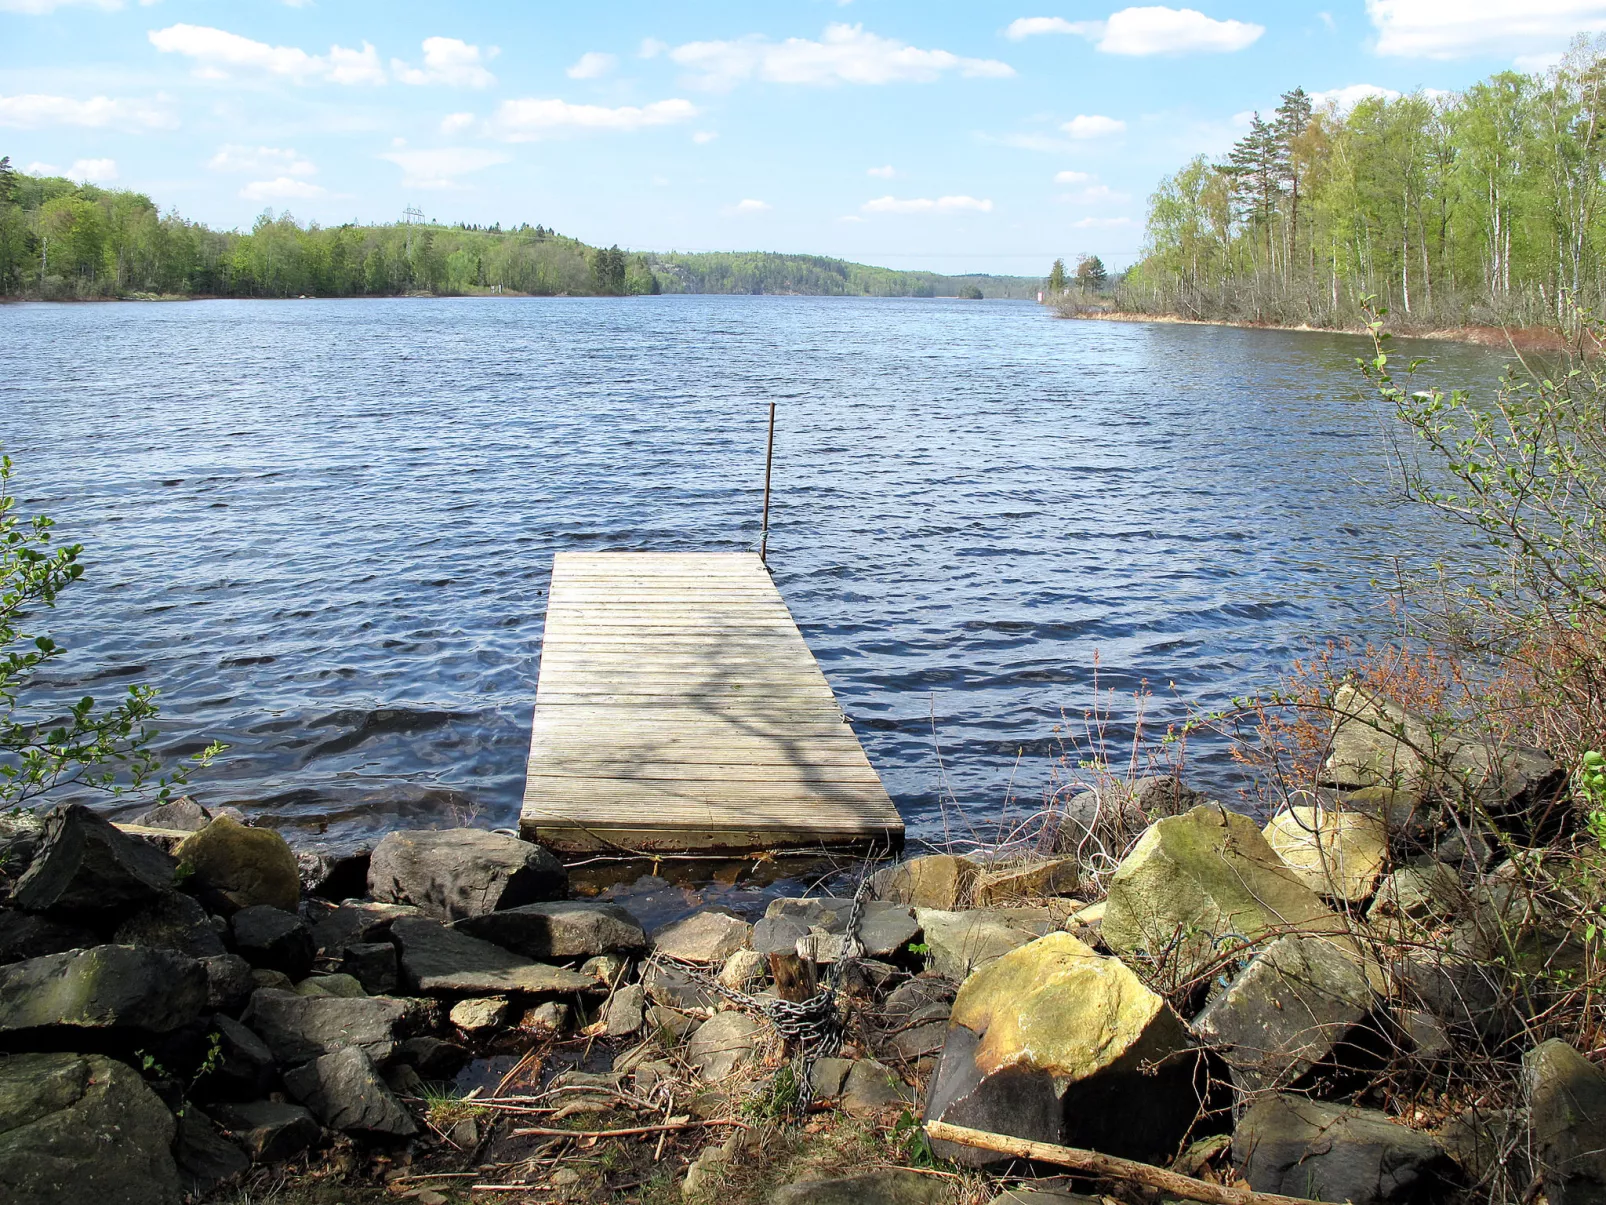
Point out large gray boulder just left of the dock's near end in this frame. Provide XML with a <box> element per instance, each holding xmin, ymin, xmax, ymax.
<box><xmin>368</xmin><ymin>829</ymin><xmax>569</xmax><ymax>921</ymax></box>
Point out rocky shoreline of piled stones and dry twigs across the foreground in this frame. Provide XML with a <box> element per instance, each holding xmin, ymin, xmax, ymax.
<box><xmin>0</xmin><ymin>688</ymin><xmax>1606</xmax><ymax>1205</ymax></box>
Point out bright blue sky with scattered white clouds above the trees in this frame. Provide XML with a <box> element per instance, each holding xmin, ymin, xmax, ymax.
<box><xmin>0</xmin><ymin>0</ymin><xmax>1606</xmax><ymax>275</ymax></box>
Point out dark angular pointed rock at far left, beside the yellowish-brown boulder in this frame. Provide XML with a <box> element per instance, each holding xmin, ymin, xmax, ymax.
<box><xmin>14</xmin><ymin>803</ymin><xmax>178</xmax><ymax>917</ymax></box>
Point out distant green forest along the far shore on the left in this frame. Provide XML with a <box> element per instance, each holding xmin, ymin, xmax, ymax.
<box><xmin>0</xmin><ymin>159</ymin><xmax>1037</xmax><ymax>300</ymax></box>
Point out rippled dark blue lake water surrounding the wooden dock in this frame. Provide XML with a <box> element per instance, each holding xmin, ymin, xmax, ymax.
<box><xmin>0</xmin><ymin>297</ymin><xmax>1495</xmax><ymax>840</ymax></box>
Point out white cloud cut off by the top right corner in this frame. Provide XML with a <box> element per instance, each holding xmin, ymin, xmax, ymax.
<box><xmin>1367</xmin><ymin>0</ymin><xmax>1606</xmax><ymax>58</ymax></box>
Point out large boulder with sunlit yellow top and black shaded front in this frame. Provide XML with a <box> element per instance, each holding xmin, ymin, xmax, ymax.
<box><xmin>925</xmin><ymin>933</ymin><xmax>1198</xmax><ymax>1165</ymax></box>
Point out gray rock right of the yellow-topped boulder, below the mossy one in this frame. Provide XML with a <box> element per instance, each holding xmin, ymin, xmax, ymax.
<box><xmin>1193</xmin><ymin>933</ymin><xmax>1372</xmax><ymax>1093</ymax></box>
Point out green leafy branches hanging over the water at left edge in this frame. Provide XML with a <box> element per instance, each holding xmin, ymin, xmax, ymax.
<box><xmin>0</xmin><ymin>456</ymin><xmax>222</xmax><ymax>807</ymax></box>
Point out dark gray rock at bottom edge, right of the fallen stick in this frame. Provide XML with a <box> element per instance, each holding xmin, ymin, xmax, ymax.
<box><xmin>1232</xmin><ymin>1094</ymin><xmax>1458</xmax><ymax>1205</ymax></box>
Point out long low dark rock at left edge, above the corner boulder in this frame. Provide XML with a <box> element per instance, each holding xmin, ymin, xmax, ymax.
<box><xmin>0</xmin><ymin>946</ymin><xmax>207</xmax><ymax>1033</ymax></box>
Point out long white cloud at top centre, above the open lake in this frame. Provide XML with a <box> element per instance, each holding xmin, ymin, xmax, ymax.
<box><xmin>670</xmin><ymin>24</ymin><xmax>1015</xmax><ymax>88</ymax></box>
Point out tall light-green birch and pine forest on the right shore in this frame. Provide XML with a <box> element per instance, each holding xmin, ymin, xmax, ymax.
<box><xmin>1111</xmin><ymin>39</ymin><xmax>1606</xmax><ymax>329</ymax></box>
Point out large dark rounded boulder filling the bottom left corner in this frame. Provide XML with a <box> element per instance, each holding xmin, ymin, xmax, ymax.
<box><xmin>0</xmin><ymin>1054</ymin><xmax>183</xmax><ymax>1205</ymax></box>
